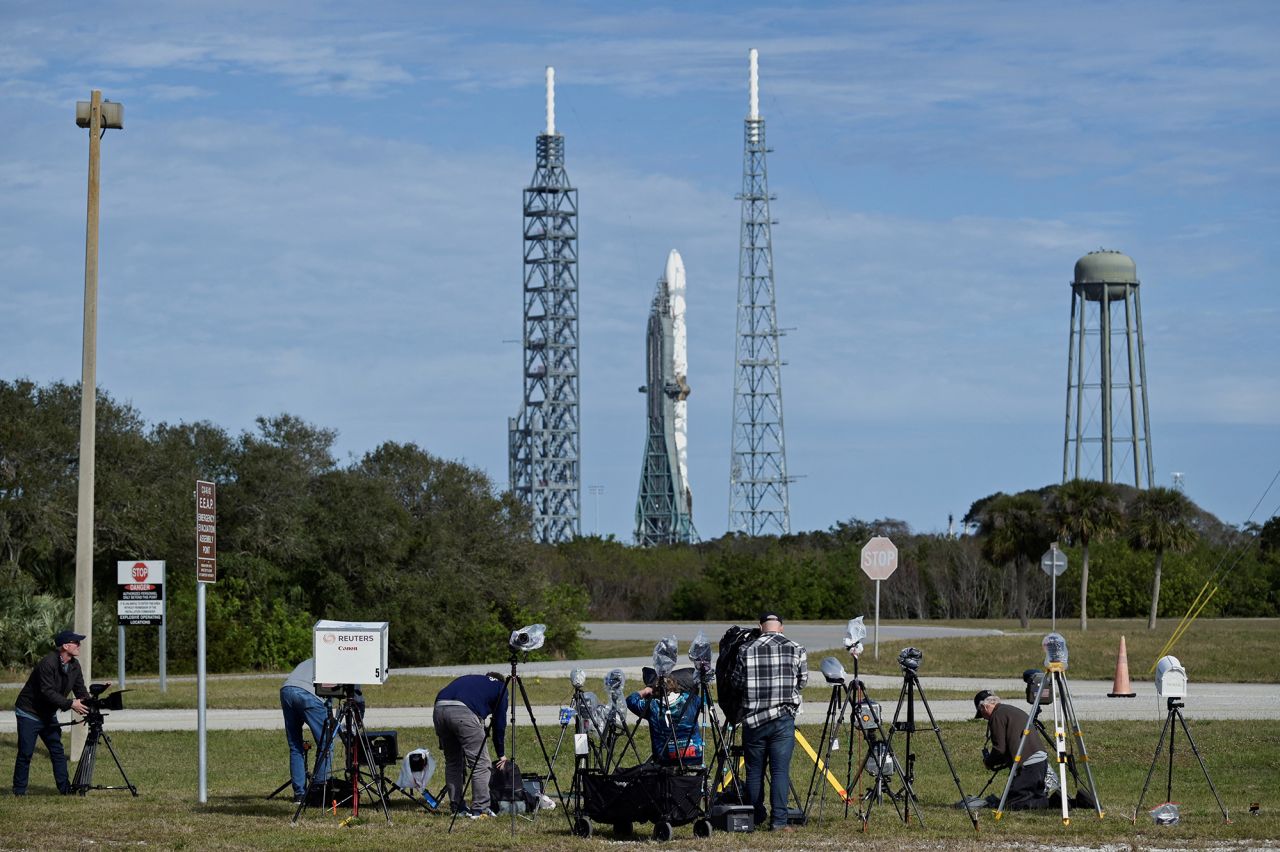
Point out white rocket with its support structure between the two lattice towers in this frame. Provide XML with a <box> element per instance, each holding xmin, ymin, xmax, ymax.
<box><xmin>636</xmin><ymin>249</ymin><xmax>698</xmax><ymax>546</ymax></box>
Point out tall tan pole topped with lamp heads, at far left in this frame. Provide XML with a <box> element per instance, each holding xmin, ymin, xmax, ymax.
<box><xmin>72</xmin><ymin>88</ymin><xmax>124</xmax><ymax>741</ymax></box>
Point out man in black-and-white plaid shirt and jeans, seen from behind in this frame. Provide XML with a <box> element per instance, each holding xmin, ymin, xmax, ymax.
<box><xmin>732</xmin><ymin>611</ymin><xmax>809</xmax><ymax>832</ymax></box>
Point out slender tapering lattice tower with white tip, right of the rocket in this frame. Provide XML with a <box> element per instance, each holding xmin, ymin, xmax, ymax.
<box><xmin>728</xmin><ymin>47</ymin><xmax>791</xmax><ymax>536</ymax></box>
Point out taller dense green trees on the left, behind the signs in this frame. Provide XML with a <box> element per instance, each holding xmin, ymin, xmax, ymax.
<box><xmin>0</xmin><ymin>380</ymin><xmax>588</xmax><ymax>672</ymax></box>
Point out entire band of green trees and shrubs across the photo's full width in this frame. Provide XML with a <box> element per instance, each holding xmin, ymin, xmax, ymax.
<box><xmin>0</xmin><ymin>380</ymin><xmax>1280</xmax><ymax>670</ymax></box>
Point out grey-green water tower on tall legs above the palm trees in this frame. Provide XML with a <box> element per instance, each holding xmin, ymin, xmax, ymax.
<box><xmin>1062</xmin><ymin>251</ymin><xmax>1155</xmax><ymax>489</ymax></box>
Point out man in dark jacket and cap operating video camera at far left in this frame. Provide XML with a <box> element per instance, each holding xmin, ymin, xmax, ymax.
<box><xmin>13</xmin><ymin>631</ymin><xmax>88</xmax><ymax>796</ymax></box>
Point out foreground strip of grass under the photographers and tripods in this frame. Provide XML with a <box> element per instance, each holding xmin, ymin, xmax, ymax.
<box><xmin>0</xmin><ymin>720</ymin><xmax>1280</xmax><ymax>851</ymax></box>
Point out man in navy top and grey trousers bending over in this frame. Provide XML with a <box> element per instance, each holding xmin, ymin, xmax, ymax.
<box><xmin>431</xmin><ymin>672</ymin><xmax>507</xmax><ymax>819</ymax></box>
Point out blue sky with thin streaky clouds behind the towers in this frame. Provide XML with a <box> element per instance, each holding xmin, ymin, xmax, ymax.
<box><xmin>0</xmin><ymin>0</ymin><xmax>1280</xmax><ymax>540</ymax></box>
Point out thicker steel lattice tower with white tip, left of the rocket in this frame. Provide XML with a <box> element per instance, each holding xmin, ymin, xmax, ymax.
<box><xmin>508</xmin><ymin>67</ymin><xmax>582</xmax><ymax>542</ymax></box>
